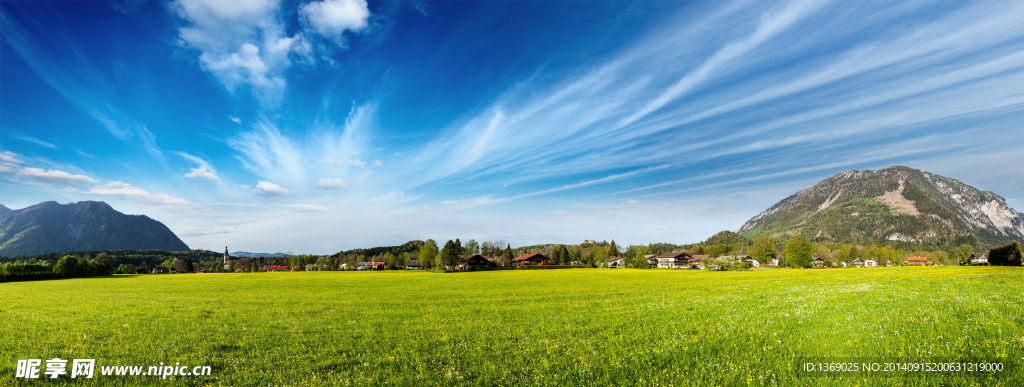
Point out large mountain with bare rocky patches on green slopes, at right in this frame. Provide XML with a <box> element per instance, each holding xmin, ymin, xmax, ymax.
<box><xmin>736</xmin><ymin>166</ymin><xmax>1024</xmax><ymax>248</ymax></box>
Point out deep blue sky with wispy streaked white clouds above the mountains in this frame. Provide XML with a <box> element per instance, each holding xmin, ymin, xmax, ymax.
<box><xmin>0</xmin><ymin>0</ymin><xmax>1024</xmax><ymax>253</ymax></box>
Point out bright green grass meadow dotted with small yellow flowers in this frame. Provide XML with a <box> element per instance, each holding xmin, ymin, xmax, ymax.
<box><xmin>0</xmin><ymin>267</ymin><xmax>1024</xmax><ymax>386</ymax></box>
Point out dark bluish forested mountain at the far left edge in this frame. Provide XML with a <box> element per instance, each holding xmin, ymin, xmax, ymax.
<box><xmin>0</xmin><ymin>202</ymin><xmax>189</xmax><ymax>257</ymax></box>
